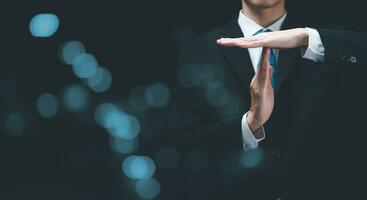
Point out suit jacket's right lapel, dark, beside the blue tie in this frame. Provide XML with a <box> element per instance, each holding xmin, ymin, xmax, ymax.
<box><xmin>275</xmin><ymin>15</ymin><xmax>300</xmax><ymax>91</ymax></box>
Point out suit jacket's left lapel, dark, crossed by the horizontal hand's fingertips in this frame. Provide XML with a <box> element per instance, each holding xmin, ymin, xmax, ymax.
<box><xmin>219</xmin><ymin>18</ymin><xmax>255</xmax><ymax>89</ymax></box>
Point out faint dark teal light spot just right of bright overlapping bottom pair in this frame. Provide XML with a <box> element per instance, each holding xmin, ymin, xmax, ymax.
<box><xmin>155</xmin><ymin>146</ymin><xmax>180</xmax><ymax>170</ymax></box>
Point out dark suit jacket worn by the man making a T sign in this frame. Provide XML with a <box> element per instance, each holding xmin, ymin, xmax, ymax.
<box><xmin>161</xmin><ymin>15</ymin><xmax>367</xmax><ymax>199</ymax></box>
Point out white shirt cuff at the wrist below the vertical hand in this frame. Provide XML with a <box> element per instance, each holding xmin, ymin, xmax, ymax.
<box><xmin>241</xmin><ymin>113</ymin><xmax>265</xmax><ymax>151</ymax></box>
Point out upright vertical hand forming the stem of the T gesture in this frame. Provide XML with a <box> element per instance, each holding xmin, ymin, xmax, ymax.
<box><xmin>246</xmin><ymin>48</ymin><xmax>274</xmax><ymax>132</ymax></box>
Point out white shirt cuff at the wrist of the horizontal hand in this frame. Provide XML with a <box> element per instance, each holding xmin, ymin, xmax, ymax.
<box><xmin>301</xmin><ymin>27</ymin><xmax>325</xmax><ymax>62</ymax></box>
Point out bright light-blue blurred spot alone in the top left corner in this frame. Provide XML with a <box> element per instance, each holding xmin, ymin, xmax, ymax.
<box><xmin>29</xmin><ymin>13</ymin><xmax>59</xmax><ymax>37</ymax></box>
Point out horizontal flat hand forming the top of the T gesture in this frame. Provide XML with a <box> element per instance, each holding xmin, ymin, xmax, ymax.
<box><xmin>217</xmin><ymin>28</ymin><xmax>309</xmax><ymax>49</ymax></box>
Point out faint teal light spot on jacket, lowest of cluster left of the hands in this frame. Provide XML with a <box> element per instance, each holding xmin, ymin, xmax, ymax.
<box><xmin>205</xmin><ymin>86</ymin><xmax>230</xmax><ymax>107</ymax></box>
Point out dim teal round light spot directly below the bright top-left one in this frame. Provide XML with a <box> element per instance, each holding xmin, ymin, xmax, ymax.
<box><xmin>36</xmin><ymin>93</ymin><xmax>59</xmax><ymax>118</ymax></box>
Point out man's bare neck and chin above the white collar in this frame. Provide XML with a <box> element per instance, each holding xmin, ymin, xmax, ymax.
<box><xmin>242</xmin><ymin>1</ymin><xmax>285</xmax><ymax>27</ymax></box>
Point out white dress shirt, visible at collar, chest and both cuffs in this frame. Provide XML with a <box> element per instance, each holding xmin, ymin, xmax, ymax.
<box><xmin>238</xmin><ymin>11</ymin><xmax>325</xmax><ymax>150</ymax></box>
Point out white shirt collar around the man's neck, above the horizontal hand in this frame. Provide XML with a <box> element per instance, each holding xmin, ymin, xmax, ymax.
<box><xmin>238</xmin><ymin>10</ymin><xmax>287</xmax><ymax>37</ymax></box>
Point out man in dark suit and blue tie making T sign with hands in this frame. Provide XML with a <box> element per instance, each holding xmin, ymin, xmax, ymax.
<box><xmin>165</xmin><ymin>0</ymin><xmax>366</xmax><ymax>199</ymax></box>
